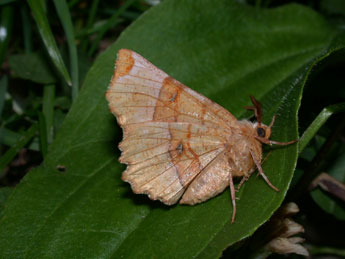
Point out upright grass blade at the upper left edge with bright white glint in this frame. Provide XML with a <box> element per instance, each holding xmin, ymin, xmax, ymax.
<box><xmin>0</xmin><ymin>5</ymin><xmax>13</xmax><ymax>67</ymax></box>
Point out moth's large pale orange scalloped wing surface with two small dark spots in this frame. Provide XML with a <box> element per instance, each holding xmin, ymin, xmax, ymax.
<box><xmin>106</xmin><ymin>49</ymin><xmax>237</xmax><ymax>204</ymax></box>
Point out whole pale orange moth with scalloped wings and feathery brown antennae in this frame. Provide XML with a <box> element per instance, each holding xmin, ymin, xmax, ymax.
<box><xmin>106</xmin><ymin>49</ymin><xmax>295</xmax><ymax>222</ymax></box>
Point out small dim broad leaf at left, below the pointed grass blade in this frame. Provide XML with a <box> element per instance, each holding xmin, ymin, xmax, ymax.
<box><xmin>9</xmin><ymin>53</ymin><xmax>56</xmax><ymax>84</ymax></box>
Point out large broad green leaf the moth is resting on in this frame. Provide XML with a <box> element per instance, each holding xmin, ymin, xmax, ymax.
<box><xmin>0</xmin><ymin>0</ymin><xmax>345</xmax><ymax>258</ymax></box>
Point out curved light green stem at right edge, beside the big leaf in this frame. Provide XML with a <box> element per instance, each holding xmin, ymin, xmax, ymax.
<box><xmin>298</xmin><ymin>103</ymin><xmax>345</xmax><ymax>153</ymax></box>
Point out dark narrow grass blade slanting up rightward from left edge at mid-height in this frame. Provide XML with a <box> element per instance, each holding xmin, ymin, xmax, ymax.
<box><xmin>0</xmin><ymin>123</ymin><xmax>37</xmax><ymax>172</ymax></box>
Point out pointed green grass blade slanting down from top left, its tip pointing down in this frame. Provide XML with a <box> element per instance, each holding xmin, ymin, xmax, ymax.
<box><xmin>27</xmin><ymin>0</ymin><xmax>72</xmax><ymax>85</ymax></box>
